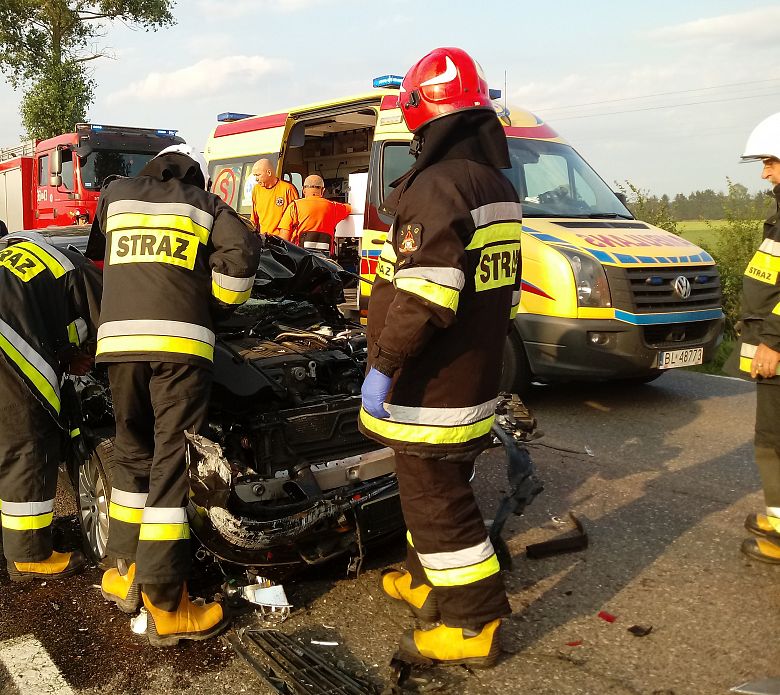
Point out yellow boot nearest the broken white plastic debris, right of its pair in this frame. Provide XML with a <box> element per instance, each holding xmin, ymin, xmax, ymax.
<box><xmin>141</xmin><ymin>584</ymin><xmax>229</xmax><ymax>647</ymax></box>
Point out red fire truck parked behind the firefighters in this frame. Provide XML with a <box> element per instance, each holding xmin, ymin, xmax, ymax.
<box><xmin>0</xmin><ymin>123</ymin><xmax>184</xmax><ymax>232</ymax></box>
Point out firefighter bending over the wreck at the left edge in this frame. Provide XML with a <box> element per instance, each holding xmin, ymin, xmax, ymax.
<box><xmin>0</xmin><ymin>232</ymin><xmax>102</xmax><ymax>581</ymax></box>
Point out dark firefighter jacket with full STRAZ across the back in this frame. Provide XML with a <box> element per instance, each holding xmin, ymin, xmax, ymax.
<box><xmin>88</xmin><ymin>154</ymin><xmax>259</xmax><ymax>368</ymax></box>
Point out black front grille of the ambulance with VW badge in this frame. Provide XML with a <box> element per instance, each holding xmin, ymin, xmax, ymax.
<box><xmin>605</xmin><ymin>265</ymin><xmax>721</xmax><ymax>314</ymax></box>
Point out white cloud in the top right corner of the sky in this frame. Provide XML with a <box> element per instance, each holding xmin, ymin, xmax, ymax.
<box><xmin>648</xmin><ymin>6</ymin><xmax>780</xmax><ymax>47</ymax></box>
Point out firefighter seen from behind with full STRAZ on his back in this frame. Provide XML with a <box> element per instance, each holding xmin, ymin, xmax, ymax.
<box><xmin>87</xmin><ymin>145</ymin><xmax>259</xmax><ymax>646</ymax></box>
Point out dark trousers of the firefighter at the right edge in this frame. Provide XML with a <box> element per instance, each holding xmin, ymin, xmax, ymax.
<box><xmin>755</xmin><ymin>383</ymin><xmax>780</xmax><ymax>517</ymax></box>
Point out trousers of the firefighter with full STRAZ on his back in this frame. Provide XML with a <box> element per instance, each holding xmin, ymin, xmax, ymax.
<box><xmin>108</xmin><ymin>362</ymin><xmax>211</xmax><ymax>584</ymax></box>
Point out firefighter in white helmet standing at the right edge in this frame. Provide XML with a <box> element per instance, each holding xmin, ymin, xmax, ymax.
<box><xmin>734</xmin><ymin>113</ymin><xmax>780</xmax><ymax>565</ymax></box>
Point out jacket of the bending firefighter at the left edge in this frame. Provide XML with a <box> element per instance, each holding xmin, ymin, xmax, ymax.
<box><xmin>0</xmin><ymin>232</ymin><xmax>102</xmax><ymax>426</ymax></box>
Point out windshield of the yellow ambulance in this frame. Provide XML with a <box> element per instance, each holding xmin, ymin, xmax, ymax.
<box><xmin>504</xmin><ymin>137</ymin><xmax>633</xmax><ymax>219</ymax></box>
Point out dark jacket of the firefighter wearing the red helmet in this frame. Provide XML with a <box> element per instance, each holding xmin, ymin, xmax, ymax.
<box><xmin>360</xmin><ymin>114</ymin><xmax>521</xmax><ymax>460</ymax></box>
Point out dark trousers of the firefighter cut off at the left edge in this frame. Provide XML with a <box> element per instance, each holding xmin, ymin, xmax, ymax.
<box><xmin>0</xmin><ymin>357</ymin><xmax>64</xmax><ymax>563</ymax></box>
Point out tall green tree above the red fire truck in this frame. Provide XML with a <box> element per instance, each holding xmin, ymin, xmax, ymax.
<box><xmin>0</xmin><ymin>0</ymin><xmax>174</xmax><ymax>138</ymax></box>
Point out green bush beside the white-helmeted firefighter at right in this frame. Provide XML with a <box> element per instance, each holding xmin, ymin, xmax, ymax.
<box><xmin>705</xmin><ymin>179</ymin><xmax>773</xmax><ymax>338</ymax></box>
